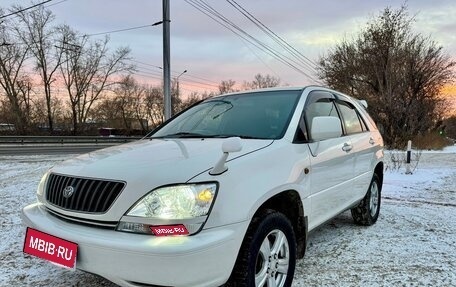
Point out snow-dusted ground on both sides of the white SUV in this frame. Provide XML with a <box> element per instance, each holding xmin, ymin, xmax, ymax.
<box><xmin>0</xmin><ymin>146</ymin><xmax>456</xmax><ymax>287</ymax></box>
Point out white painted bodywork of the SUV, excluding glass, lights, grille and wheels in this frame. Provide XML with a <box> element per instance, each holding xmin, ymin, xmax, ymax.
<box><xmin>22</xmin><ymin>87</ymin><xmax>383</xmax><ymax>287</ymax></box>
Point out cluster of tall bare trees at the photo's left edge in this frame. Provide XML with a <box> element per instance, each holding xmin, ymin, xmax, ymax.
<box><xmin>0</xmin><ymin>5</ymin><xmax>134</xmax><ymax>134</ymax></box>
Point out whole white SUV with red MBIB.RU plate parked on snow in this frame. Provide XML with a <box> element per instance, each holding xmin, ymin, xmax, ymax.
<box><xmin>22</xmin><ymin>86</ymin><xmax>383</xmax><ymax>287</ymax></box>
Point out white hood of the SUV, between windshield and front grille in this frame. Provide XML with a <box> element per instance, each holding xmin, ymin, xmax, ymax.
<box><xmin>48</xmin><ymin>139</ymin><xmax>273</xmax><ymax>221</ymax></box>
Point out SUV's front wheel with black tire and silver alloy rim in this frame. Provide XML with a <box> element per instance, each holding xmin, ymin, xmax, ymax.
<box><xmin>225</xmin><ymin>210</ymin><xmax>296</xmax><ymax>287</ymax></box>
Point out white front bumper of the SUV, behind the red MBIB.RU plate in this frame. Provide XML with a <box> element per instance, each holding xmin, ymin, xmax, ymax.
<box><xmin>22</xmin><ymin>203</ymin><xmax>248</xmax><ymax>287</ymax></box>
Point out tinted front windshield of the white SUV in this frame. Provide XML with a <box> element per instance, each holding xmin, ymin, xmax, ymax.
<box><xmin>151</xmin><ymin>90</ymin><xmax>302</xmax><ymax>139</ymax></box>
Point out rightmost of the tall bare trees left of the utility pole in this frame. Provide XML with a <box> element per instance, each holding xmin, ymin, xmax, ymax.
<box><xmin>59</xmin><ymin>26</ymin><xmax>134</xmax><ymax>134</ymax></box>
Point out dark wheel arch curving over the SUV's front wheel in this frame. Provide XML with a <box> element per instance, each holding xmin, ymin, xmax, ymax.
<box><xmin>253</xmin><ymin>190</ymin><xmax>308</xmax><ymax>258</ymax></box>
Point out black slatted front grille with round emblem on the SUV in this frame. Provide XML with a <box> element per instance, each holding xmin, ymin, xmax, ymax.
<box><xmin>46</xmin><ymin>174</ymin><xmax>125</xmax><ymax>213</ymax></box>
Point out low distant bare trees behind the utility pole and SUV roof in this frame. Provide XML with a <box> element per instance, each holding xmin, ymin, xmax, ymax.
<box><xmin>92</xmin><ymin>74</ymin><xmax>280</xmax><ymax>135</ymax></box>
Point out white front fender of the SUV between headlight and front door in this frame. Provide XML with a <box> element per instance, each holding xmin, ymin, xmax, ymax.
<box><xmin>192</xmin><ymin>141</ymin><xmax>310</xmax><ymax>228</ymax></box>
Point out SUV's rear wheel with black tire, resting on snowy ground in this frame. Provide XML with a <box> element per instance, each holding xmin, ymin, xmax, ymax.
<box><xmin>351</xmin><ymin>173</ymin><xmax>382</xmax><ymax>226</ymax></box>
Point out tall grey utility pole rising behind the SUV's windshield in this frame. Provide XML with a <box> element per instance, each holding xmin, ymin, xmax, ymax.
<box><xmin>163</xmin><ymin>0</ymin><xmax>172</xmax><ymax>120</ymax></box>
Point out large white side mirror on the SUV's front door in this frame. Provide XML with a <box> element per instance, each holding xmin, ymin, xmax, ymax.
<box><xmin>310</xmin><ymin>117</ymin><xmax>342</xmax><ymax>141</ymax></box>
